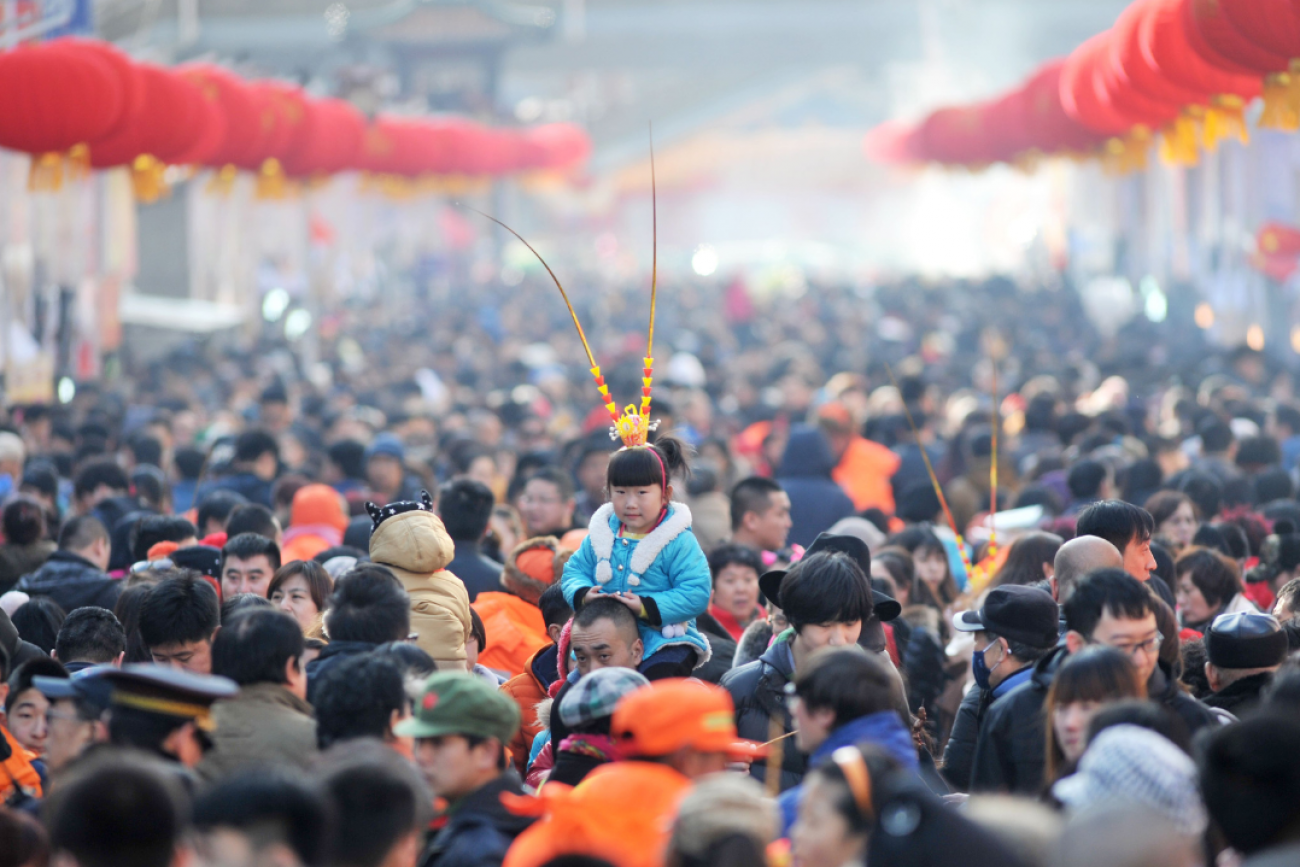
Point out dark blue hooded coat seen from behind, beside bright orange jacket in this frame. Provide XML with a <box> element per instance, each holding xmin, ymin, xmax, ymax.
<box><xmin>776</xmin><ymin>426</ymin><xmax>857</xmax><ymax>547</ymax></box>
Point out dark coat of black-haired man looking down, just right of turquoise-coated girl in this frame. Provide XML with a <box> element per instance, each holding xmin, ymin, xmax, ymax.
<box><xmin>722</xmin><ymin>641</ymin><xmax>807</xmax><ymax>792</ymax></box>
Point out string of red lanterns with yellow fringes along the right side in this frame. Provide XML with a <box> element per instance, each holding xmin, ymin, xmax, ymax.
<box><xmin>865</xmin><ymin>0</ymin><xmax>1300</xmax><ymax>170</ymax></box>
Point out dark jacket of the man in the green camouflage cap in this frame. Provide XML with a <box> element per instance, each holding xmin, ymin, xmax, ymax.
<box><xmin>420</xmin><ymin>771</ymin><xmax>533</xmax><ymax>867</ymax></box>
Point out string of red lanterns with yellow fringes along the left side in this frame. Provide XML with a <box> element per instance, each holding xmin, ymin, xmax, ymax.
<box><xmin>0</xmin><ymin>38</ymin><xmax>592</xmax><ymax>195</ymax></box>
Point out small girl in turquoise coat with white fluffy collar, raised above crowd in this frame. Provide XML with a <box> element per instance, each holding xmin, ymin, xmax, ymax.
<box><xmin>560</xmin><ymin>437</ymin><xmax>712</xmax><ymax>680</ymax></box>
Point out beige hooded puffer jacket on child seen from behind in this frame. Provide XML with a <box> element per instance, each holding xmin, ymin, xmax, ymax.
<box><xmin>371</xmin><ymin>510</ymin><xmax>471</xmax><ymax>669</ymax></box>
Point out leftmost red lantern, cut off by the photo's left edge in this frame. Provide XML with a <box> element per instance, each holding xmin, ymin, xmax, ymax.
<box><xmin>0</xmin><ymin>42</ymin><xmax>127</xmax><ymax>153</ymax></box>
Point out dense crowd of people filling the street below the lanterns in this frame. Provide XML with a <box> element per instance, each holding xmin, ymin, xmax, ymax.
<box><xmin>0</xmin><ymin>279</ymin><xmax>1300</xmax><ymax>867</ymax></box>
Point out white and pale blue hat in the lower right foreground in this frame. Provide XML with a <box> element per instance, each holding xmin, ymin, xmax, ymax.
<box><xmin>1052</xmin><ymin>725</ymin><xmax>1206</xmax><ymax>836</ymax></box>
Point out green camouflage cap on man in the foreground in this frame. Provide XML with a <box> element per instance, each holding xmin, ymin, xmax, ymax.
<box><xmin>394</xmin><ymin>671</ymin><xmax>520</xmax><ymax>744</ymax></box>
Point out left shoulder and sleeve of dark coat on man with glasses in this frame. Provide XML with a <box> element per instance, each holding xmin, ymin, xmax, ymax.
<box><xmin>970</xmin><ymin>647</ymin><xmax>1069</xmax><ymax>796</ymax></box>
